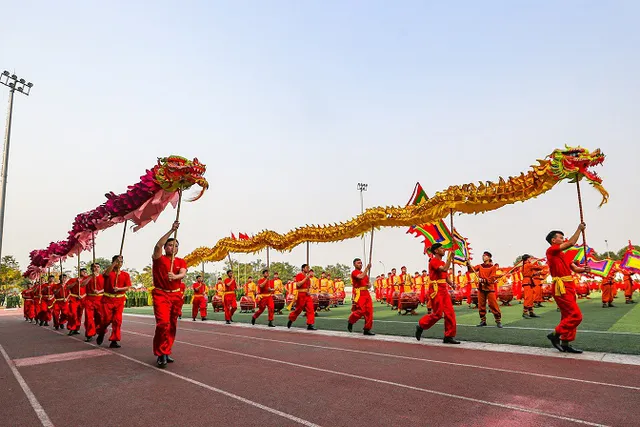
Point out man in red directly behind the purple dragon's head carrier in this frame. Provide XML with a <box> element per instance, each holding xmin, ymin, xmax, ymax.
<box><xmin>96</xmin><ymin>255</ymin><xmax>131</xmax><ymax>348</ymax></box>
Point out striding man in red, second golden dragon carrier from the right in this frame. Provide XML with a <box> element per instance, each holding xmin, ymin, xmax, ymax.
<box><xmin>416</xmin><ymin>243</ymin><xmax>460</xmax><ymax>344</ymax></box>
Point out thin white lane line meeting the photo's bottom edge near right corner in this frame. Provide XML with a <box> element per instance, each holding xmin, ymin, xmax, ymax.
<box><xmin>127</xmin><ymin>331</ymin><xmax>606</xmax><ymax>427</ymax></box>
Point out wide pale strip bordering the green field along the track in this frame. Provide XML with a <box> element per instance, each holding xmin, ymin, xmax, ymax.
<box><xmin>125</xmin><ymin>314</ymin><xmax>640</xmax><ymax>366</ymax></box>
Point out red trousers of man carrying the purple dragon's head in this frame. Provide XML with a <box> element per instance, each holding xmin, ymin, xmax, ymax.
<box><xmin>151</xmin><ymin>288</ymin><xmax>180</xmax><ymax>356</ymax></box>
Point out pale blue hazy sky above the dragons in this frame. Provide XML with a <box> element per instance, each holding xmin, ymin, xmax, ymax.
<box><xmin>0</xmin><ymin>0</ymin><xmax>640</xmax><ymax>274</ymax></box>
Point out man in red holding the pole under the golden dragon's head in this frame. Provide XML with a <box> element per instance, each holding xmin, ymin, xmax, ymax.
<box><xmin>546</xmin><ymin>223</ymin><xmax>591</xmax><ymax>353</ymax></box>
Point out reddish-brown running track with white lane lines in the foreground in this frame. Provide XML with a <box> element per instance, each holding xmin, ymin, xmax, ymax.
<box><xmin>0</xmin><ymin>315</ymin><xmax>640</xmax><ymax>427</ymax></box>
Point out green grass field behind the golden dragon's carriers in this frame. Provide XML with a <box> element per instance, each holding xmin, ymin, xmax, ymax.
<box><xmin>125</xmin><ymin>292</ymin><xmax>640</xmax><ymax>354</ymax></box>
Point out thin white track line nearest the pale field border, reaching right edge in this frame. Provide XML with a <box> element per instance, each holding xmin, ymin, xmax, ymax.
<box><xmin>127</xmin><ymin>320</ymin><xmax>640</xmax><ymax>391</ymax></box>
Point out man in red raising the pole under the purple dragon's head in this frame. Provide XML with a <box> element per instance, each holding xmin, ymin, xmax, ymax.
<box><xmin>152</xmin><ymin>221</ymin><xmax>187</xmax><ymax>369</ymax></box>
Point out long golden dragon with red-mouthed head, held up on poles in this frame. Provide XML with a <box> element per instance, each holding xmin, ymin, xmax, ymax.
<box><xmin>185</xmin><ymin>147</ymin><xmax>609</xmax><ymax>266</ymax></box>
